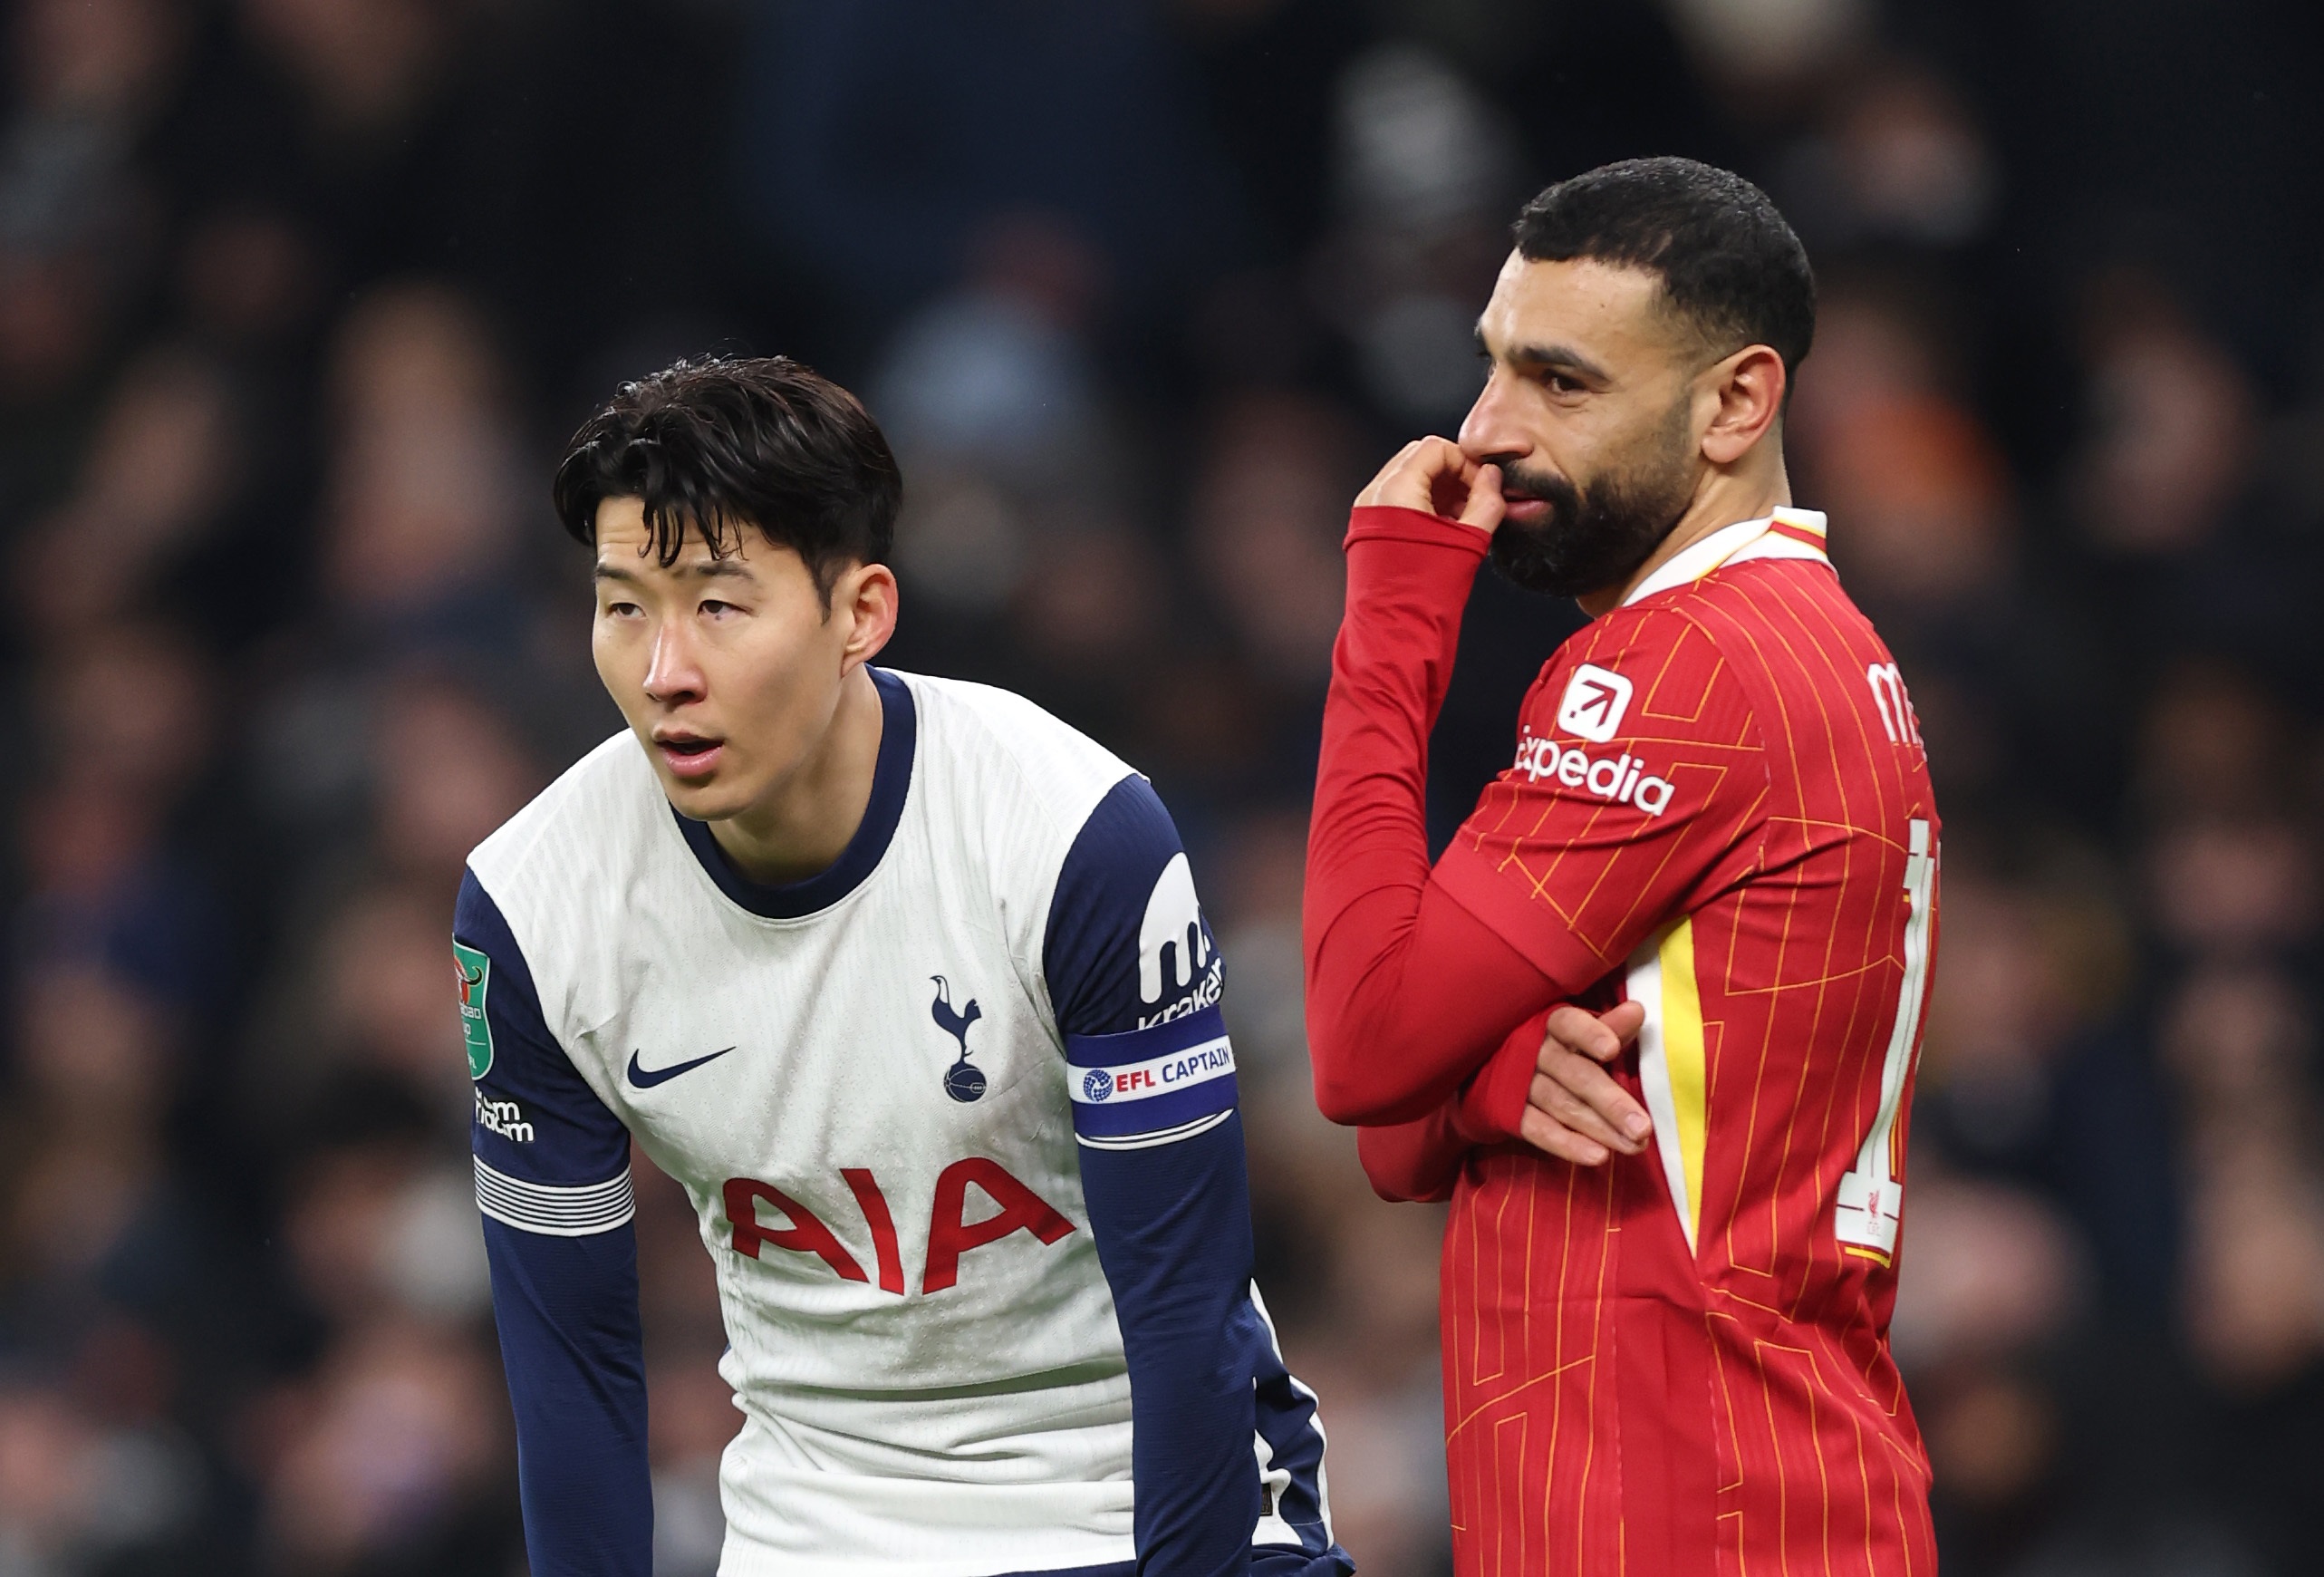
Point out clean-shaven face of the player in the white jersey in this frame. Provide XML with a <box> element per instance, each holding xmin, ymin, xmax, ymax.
<box><xmin>591</xmin><ymin>498</ymin><xmax>853</xmax><ymax>821</ymax></box>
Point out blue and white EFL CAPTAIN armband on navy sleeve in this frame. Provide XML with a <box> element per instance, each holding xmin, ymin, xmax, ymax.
<box><xmin>1065</xmin><ymin>1007</ymin><xmax>1234</xmax><ymax>1149</ymax></box>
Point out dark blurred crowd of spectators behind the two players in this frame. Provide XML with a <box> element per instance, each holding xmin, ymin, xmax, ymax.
<box><xmin>0</xmin><ymin>0</ymin><xmax>2324</xmax><ymax>1577</ymax></box>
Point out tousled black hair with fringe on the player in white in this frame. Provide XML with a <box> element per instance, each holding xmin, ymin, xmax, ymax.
<box><xmin>551</xmin><ymin>356</ymin><xmax>904</xmax><ymax>600</ymax></box>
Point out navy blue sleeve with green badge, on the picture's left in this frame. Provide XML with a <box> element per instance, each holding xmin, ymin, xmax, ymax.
<box><xmin>453</xmin><ymin>872</ymin><xmax>653</xmax><ymax>1577</ymax></box>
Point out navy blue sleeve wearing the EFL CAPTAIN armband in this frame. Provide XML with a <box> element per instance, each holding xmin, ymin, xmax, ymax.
<box><xmin>1044</xmin><ymin>777</ymin><xmax>1353</xmax><ymax>1577</ymax></box>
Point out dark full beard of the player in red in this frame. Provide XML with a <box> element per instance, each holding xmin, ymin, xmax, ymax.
<box><xmin>1490</xmin><ymin>402</ymin><xmax>1694</xmax><ymax>598</ymax></box>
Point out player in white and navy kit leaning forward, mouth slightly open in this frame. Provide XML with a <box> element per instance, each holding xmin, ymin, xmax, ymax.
<box><xmin>453</xmin><ymin>358</ymin><xmax>1353</xmax><ymax>1577</ymax></box>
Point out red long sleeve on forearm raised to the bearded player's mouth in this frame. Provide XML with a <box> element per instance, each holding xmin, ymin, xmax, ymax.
<box><xmin>1304</xmin><ymin>509</ymin><xmax>1557</xmax><ymax>1126</ymax></box>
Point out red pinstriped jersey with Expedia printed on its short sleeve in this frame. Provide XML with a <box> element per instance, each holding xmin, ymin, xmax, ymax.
<box><xmin>1434</xmin><ymin>509</ymin><xmax>1938</xmax><ymax>1577</ymax></box>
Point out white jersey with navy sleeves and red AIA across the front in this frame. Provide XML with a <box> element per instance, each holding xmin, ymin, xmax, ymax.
<box><xmin>456</xmin><ymin>672</ymin><xmax>1344</xmax><ymax>1577</ymax></box>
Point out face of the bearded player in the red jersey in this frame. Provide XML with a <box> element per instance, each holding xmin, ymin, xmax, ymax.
<box><xmin>1460</xmin><ymin>251</ymin><xmax>1703</xmax><ymax>598</ymax></box>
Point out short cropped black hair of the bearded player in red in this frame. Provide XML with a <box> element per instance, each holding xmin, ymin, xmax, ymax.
<box><xmin>1513</xmin><ymin>159</ymin><xmax>1815</xmax><ymax>402</ymax></box>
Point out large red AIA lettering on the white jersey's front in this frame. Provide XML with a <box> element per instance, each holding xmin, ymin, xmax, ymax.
<box><xmin>720</xmin><ymin>1156</ymin><xmax>1074</xmax><ymax>1295</ymax></box>
